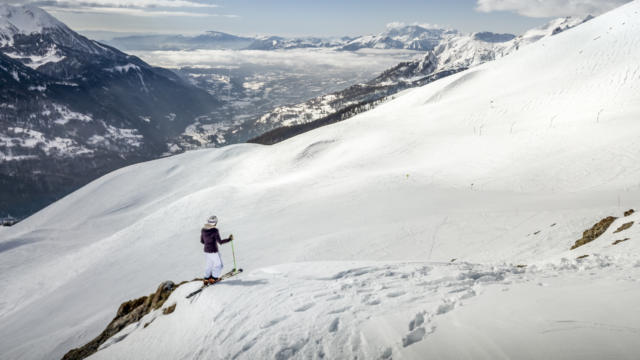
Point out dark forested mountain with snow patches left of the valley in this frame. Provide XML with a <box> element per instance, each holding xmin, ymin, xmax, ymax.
<box><xmin>0</xmin><ymin>5</ymin><xmax>217</xmax><ymax>217</ymax></box>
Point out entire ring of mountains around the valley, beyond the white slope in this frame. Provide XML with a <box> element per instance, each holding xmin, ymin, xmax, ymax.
<box><xmin>0</xmin><ymin>5</ymin><xmax>584</xmax><ymax>221</ymax></box>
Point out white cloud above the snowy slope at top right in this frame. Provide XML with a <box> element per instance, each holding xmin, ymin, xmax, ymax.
<box><xmin>476</xmin><ymin>0</ymin><xmax>630</xmax><ymax>18</ymax></box>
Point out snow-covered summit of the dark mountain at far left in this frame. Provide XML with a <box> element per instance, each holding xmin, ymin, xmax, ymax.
<box><xmin>0</xmin><ymin>4</ymin><xmax>66</xmax><ymax>35</ymax></box>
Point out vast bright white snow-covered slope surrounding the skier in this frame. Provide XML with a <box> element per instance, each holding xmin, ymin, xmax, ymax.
<box><xmin>0</xmin><ymin>1</ymin><xmax>640</xmax><ymax>359</ymax></box>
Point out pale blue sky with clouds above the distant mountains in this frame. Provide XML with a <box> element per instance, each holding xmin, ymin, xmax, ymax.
<box><xmin>0</xmin><ymin>0</ymin><xmax>628</xmax><ymax>36</ymax></box>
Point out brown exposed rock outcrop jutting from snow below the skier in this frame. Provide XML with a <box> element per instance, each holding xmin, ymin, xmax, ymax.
<box><xmin>62</xmin><ymin>281</ymin><xmax>177</xmax><ymax>360</ymax></box>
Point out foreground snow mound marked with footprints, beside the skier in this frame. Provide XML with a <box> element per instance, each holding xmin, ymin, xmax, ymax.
<box><xmin>91</xmin><ymin>261</ymin><xmax>640</xmax><ymax>359</ymax></box>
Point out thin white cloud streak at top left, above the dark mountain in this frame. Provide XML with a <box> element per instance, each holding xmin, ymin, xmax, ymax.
<box><xmin>5</xmin><ymin>0</ymin><xmax>235</xmax><ymax>17</ymax></box>
